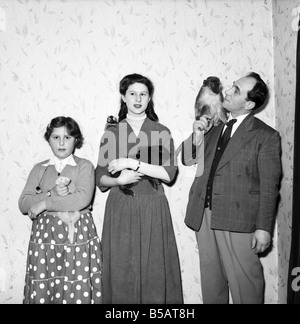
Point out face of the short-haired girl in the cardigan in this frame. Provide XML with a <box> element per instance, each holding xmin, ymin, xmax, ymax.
<box><xmin>49</xmin><ymin>126</ymin><xmax>75</xmax><ymax>160</ymax></box>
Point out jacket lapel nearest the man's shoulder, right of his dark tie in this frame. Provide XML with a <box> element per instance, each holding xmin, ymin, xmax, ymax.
<box><xmin>217</xmin><ymin>114</ymin><xmax>256</xmax><ymax>171</ymax></box>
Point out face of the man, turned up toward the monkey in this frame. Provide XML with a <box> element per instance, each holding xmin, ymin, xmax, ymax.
<box><xmin>223</xmin><ymin>77</ymin><xmax>256</xmax><ymax>116</ymax></box>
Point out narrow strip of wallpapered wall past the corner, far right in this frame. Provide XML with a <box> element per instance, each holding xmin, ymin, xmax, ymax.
<box><xmin>273</xmin><ymin>0</ymin><xmax>300</xmax><ymax>303</ymax></box>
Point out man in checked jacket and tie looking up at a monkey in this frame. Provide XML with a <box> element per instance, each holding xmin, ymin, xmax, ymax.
<box><xmin>182</xmin><ymin>72</ymin><xmax>281</xmax><ymax>304</ymax></box>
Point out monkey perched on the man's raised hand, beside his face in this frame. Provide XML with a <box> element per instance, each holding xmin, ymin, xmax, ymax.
<box><xmin>195</xmin><ymin>77</ymin><xmax>226</xmax><ymax>126</ymax></box>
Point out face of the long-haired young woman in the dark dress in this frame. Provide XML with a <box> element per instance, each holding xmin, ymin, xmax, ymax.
<box><xmin>122</xmin><ymin>83</ymin><xmax>151</xmax><ymax>116</ymax></box>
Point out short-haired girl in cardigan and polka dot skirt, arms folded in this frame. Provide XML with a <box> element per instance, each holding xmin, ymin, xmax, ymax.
<box><xmin>19</xmin><ymin>117</ymin><xmax>102</xmax><ymax>304</ymax></box>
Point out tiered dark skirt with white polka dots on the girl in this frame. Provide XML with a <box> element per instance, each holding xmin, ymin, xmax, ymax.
<box><xmin>23</xmin><ymin>213</ymin><xmax>102</xmax><ymax>304</ymax></box>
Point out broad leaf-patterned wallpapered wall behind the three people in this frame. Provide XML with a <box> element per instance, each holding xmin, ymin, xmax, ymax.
<box><xmin>0</xmin><ymin>0</ymin><xmax>288</xmax><ymax>303</ymax></box>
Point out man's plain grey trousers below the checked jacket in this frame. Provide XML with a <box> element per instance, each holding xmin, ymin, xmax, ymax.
<box><xmin>196</xmin><ymin>208</ymin><xmax>264</xmax><ymax>304</ymax></box>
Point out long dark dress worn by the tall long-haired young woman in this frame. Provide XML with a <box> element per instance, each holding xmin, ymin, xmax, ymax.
<box><xmin>96</xmin><ymin>118</ymin><xmax>183</xmax><ymax>304</ymax></box>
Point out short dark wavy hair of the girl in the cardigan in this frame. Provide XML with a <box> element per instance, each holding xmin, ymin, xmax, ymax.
<box><xmin>44</xmin><ymin>116</ymin><xmax>84</xmax><ymax>149</ymax></box>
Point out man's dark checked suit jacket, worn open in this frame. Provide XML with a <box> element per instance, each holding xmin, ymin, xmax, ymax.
<box><xmin>182</xmin><ymin>114</ymin><xmax>281</xmax><ymax>233</ymax></box>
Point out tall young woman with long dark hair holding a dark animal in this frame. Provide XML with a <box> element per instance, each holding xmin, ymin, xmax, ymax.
<box><xmin>96</xmin><ymin>74</ymin><xmax>183</xmax><ymax>304</ymax></box>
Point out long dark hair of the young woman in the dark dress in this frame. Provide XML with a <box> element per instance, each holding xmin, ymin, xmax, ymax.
<box><xmin>119</xmin><ymin>73</ymin><xmax>158</xmax><ymax>122</ymax></box>
